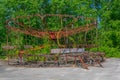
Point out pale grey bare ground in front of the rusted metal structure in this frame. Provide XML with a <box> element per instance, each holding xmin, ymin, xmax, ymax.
<box><xmin>0</xmin><ymin>58</ymin><xmax>120</xmax><ymax>80</ymax></box>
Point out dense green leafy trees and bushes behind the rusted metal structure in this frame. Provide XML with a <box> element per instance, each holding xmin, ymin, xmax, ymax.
<box><xmin>0</xmin><ymin>0</ymin><xmax>120</xmax><ymax>57</ymax></box>
